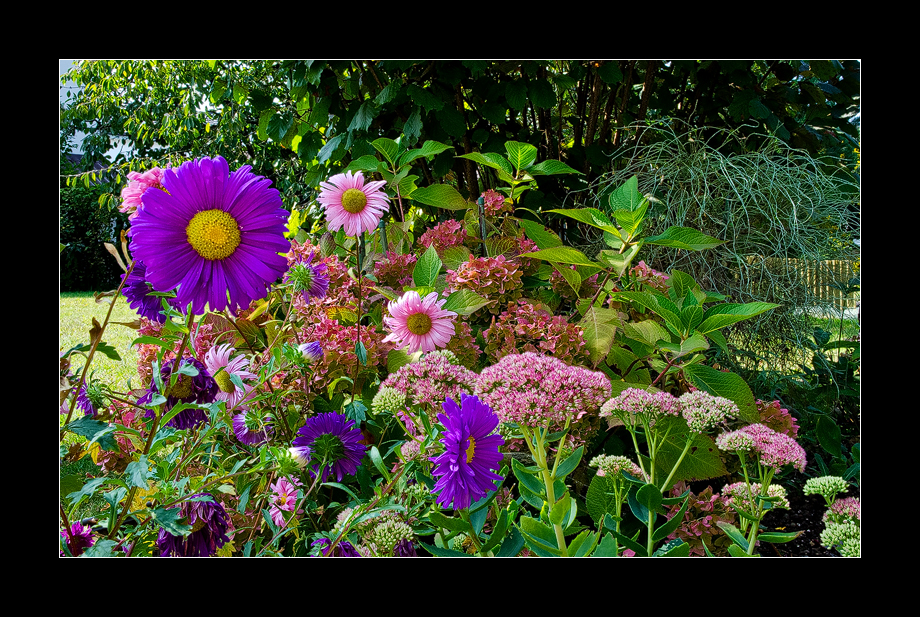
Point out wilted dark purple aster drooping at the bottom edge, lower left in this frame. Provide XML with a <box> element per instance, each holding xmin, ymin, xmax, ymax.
<box><xmin>157</xmin><ymin>493</ymin><xmax>230</xmax><ymax>557</ymax></box>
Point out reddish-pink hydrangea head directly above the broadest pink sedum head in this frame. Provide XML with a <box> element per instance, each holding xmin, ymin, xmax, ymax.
<box><xmin>482</xmin><ymin>300</ymin><xmax>588</xmax><ymax>364</ymax></box>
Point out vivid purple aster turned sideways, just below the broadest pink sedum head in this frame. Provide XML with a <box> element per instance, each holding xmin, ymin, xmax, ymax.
<box><xmin>429</xmin><ymin>394</ymin><xmax>505</xmax><ymax>510</ymax></box>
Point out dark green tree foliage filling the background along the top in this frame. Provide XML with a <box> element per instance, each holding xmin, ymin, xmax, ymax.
<box><xmin>61</xmin><ymin>60</ymin><xmax>859</xmax><ymax>215</ymax></box>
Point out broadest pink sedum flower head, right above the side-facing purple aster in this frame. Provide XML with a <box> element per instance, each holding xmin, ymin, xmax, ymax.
<box><xmin>475</xmin><ymin>352</ymin><xmax>611</xmax><ymax>447</ymax></box>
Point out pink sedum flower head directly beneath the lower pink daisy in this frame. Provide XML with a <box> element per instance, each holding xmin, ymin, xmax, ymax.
<box><xmin>380</xmin><ymin>352</ymin><xmax>477</xmax><ymax>422</ymax></box>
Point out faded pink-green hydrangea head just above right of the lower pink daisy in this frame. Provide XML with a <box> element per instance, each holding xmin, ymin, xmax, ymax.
<box><xmin>447</xmin><ymin>255</ymin><xmax>523</xmax><ymax>315</ymax></box>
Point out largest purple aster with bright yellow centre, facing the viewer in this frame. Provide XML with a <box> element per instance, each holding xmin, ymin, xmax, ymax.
<box><xmin>129</xmin><ymin>156</ymin><xmax>290</xmax><ymax>313</ymax></box>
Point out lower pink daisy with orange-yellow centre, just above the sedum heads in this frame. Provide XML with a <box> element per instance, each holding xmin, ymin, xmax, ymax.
<box><xmin>383</xmin><ymin>291</ymin><xmax>457</xmax><ymax>353</ymax></box>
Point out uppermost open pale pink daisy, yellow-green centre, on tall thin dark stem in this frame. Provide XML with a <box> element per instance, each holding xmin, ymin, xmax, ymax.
<box><xmin>317</xmin><ymin>171</ymin><xmax>390</xmax><ymax>237</ymax></box>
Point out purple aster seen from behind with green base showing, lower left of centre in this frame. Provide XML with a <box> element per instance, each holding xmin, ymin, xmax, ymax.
<box><xmin>293</xmin><ymin>413</ymin><xmax>367</xmax><ymax>482</ymax></box>
